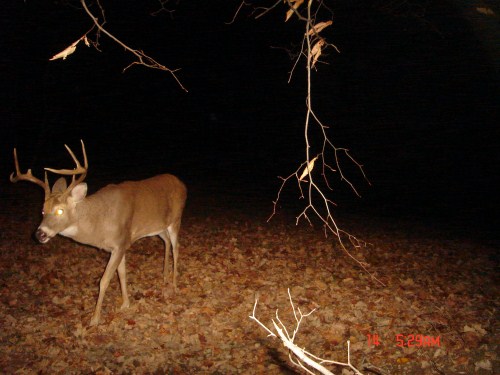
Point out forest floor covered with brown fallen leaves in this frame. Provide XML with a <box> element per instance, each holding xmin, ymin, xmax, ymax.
<box><xmin>0</xmin><ymin>186</ymin><xmax>500</xmax><ymax>374</ymax></box>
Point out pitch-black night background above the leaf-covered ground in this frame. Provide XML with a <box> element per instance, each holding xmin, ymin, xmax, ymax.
<box><xmin>0</xmin><ymin>0</ymin><xmax>499</xmax><ymax>238</ymax></box>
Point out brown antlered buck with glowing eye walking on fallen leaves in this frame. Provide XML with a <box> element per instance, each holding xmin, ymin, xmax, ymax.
<box><xmin>10</xmin><ymin>141</ymin><xmax>187</xmax><ymax>326</ymax></box>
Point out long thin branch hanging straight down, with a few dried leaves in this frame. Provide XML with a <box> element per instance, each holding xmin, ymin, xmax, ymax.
<box><xmin>258</xmin><ymin>0</ymin><xmax>385</xmax><ymax>286</ymax></box>
